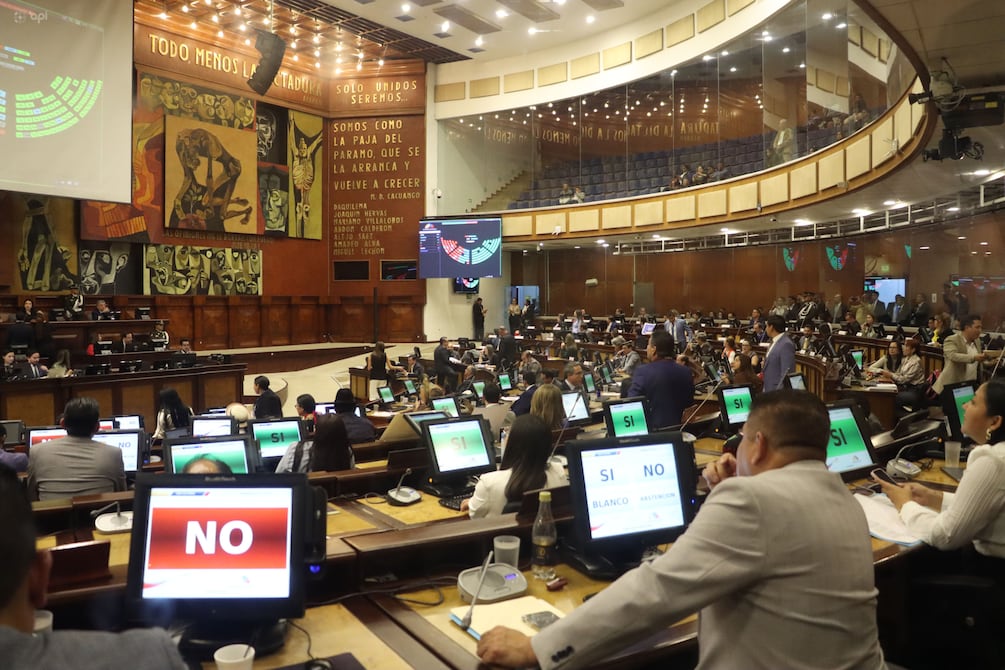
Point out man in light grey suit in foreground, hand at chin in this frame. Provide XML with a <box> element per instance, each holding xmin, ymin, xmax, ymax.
<box><xmin>477</xmin><ymin>390</ymin><xmax>886</xmax><ymax>670</ymax></box>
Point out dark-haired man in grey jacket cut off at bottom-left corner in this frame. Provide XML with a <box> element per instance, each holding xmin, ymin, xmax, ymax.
<box><xmin>0</xmin><ymin>464</ymin><xmax>187</xmax><ymax>670</ymax></box>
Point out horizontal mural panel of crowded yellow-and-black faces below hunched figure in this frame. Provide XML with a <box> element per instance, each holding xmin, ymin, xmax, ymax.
<box><xmin>143</xmin><ymin>244</ymin><xmax>262</xmax><ymax>295</ymax></box>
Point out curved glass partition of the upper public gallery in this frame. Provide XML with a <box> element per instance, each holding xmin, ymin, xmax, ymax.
<box><xmin>436</xmin><ymin>0</ymin><xmax>914</xmax><ymax>214</ymax></box>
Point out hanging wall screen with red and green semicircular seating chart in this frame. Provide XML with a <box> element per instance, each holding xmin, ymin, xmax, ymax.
<box><xmin>419</xmin><ymin>216</ymin><xmax>503</xmax><ymax>279</ymax></box>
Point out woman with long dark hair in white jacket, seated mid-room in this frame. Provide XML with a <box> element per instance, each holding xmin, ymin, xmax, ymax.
<box><xmin>461</xmin><ymin>413</ymin><xmax>567</xmax><ymax>518</ymax></box>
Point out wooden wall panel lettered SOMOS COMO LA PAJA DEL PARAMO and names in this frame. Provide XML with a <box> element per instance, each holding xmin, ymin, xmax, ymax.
<box><xmin>329</xmin><ymin>117</ymin><xmax>424</xmax><ymax>259</ymax></box>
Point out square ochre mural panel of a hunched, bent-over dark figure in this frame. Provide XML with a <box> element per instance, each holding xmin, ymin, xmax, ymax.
<box><xmin>164</xmin><ymin>116</ymin><xmax>261</xmax><ymax>234</ymax></box>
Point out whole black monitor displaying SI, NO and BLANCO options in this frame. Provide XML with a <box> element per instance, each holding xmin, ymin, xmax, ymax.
<box><xmin>566</xmin><ymin>432</ymin><xmax>697</xmax><ymax>579</ymax></box>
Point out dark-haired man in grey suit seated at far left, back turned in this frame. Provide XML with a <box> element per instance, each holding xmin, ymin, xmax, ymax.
<box><xmin>28</xmin><ymin>397</ymin><xmax>126</xmax><ymax>500</ymax></box>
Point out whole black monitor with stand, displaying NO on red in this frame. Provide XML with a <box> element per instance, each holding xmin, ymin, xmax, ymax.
<box><xmin>126</xmin><ymin>473</ymin><xmax>311</xmax><ymax>657</ymax></box>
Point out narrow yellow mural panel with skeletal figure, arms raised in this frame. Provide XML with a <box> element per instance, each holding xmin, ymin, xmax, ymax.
<box><xmin>287</xmin><ymin>111</ymin><xmax>325</xmax><ymax>240</ymax></box>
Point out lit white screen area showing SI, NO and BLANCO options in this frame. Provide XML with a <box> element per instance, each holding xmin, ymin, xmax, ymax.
<box><xmin>582</xmin><ymin>442</ymin><xmax>684</xmax><ymax>539</ymax></box>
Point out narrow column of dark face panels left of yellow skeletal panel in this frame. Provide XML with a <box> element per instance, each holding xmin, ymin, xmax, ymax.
<box><xmin>256</xmin><ymin>102</ymin><xmax>289</xmax><ymax>236</ymax></box>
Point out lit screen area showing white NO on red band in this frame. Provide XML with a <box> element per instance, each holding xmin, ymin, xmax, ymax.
<box><xmin>142</xmin><ymin>486</ymin><xmax>293</xmax><ymax>599</ymax></box>
